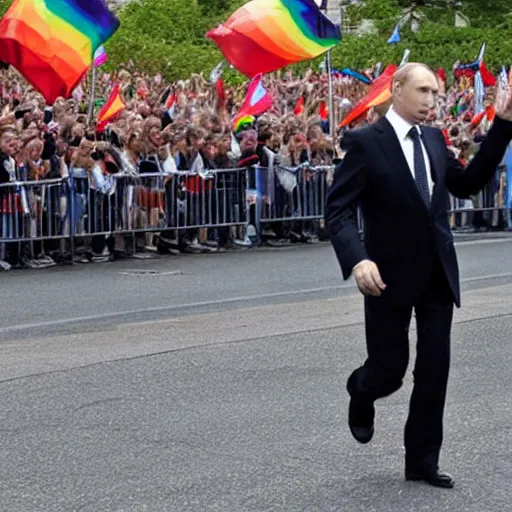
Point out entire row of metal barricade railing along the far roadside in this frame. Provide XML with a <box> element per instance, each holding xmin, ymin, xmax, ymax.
<box><xmin>0</xmin><ymin>162</ymin><xmax>512</xmax><ymax>268</ymax></box>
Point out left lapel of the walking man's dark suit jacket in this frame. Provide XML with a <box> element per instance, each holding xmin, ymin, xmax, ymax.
<box><xmin>374</xmin><ymin>117</ymin><xmax>430</xmax><ymax>213</ymax></box>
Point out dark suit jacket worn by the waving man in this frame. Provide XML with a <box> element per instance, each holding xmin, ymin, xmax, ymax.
<box><xmin>325</xmin><ymin>118</ymin><xmax>512</xmax><ymax>307</ymax></box>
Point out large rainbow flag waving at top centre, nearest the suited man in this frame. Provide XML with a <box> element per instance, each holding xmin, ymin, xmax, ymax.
<box><xmin>206</xmin><ymin>0</ymin><xmax>341</xmax><ymax>78</ymax></box>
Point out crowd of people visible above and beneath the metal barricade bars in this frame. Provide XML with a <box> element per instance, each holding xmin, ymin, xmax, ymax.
<box><xmin>0</xmin><ymin>61</ymin><xmax>506</xmax><ymax>269</ymax></box>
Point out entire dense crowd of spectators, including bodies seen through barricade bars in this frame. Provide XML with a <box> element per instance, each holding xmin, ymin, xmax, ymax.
<box><xmin>0</xmin><ymin>59</ymin><xmax>507</xmax><ymax>268</ymax></box>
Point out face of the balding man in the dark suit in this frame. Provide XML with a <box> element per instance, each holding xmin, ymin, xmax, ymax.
<box><xmin>393</xmin><ymin>67</ymin><xmax>438</xmax><ymax>124</ymax></box>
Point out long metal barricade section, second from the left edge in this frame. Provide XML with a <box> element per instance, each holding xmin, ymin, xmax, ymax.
<box><xmin>61</xmin><ymin>168</ymin><xmax>247</xmax><ymax>249</ymax></box>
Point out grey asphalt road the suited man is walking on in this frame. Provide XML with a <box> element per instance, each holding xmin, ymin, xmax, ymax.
<box><xmin>0</xmin><ymin>239</ymin><xmax>512</xmax><ymax>512</ymax></box>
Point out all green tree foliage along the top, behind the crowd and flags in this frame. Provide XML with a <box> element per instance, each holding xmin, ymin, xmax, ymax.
<box><xmin>0</xmin><ymin>0</ymin><xmax>512</xmax><ymax>81</ymax></box>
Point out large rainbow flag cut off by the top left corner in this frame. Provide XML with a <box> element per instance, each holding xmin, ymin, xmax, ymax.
<box><xmin>0</xmin><ymin>0</ymin><xmax>119</xmax><ymax>104</ymax></box>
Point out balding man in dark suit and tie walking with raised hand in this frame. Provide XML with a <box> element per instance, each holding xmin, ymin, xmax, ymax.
<box><xmin>326</xmin><ymin>63</ymin><xmax>512</xmax><ymax>488</ymax></box>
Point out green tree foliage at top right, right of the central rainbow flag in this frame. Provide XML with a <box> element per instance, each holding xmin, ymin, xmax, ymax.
<box><xmin>333</xmin><ymin>0</ymin><xmax>512</xmax><ymax>73</ymax></box>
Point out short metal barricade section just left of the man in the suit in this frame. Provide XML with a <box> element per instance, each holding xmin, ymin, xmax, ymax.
<box><xmin>247</xmin><ymin>163</ymin><xmax>334</xmax><ymax>239</ymax></box>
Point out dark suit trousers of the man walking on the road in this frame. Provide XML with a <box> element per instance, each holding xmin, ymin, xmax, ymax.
<box><xmin>351</xmin><ymin>257</ymin><xmax>453</xmax><ymax>470</ymax></box>
